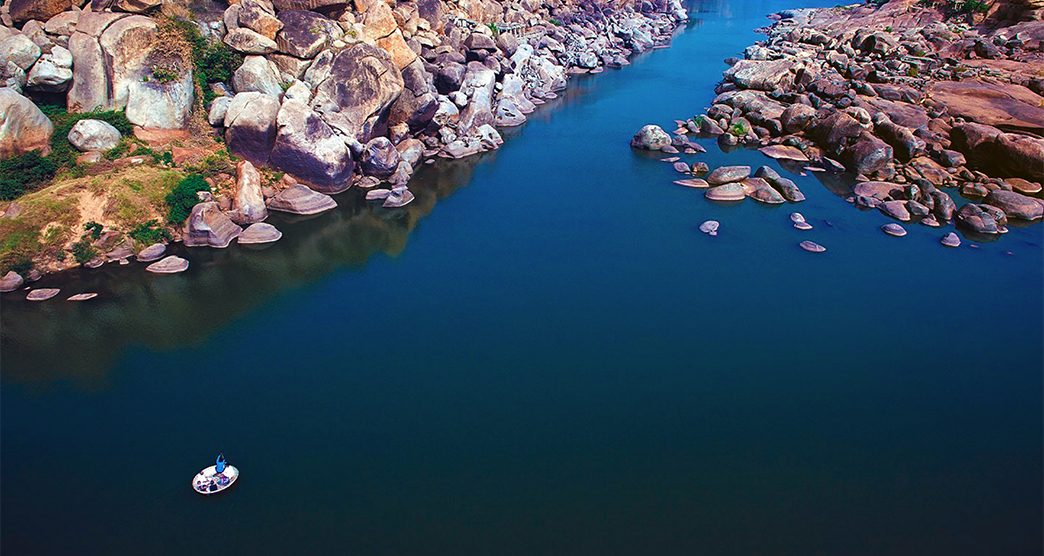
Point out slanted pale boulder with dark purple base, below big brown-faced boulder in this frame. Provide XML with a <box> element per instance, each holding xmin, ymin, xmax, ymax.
<box><xmin>270</xmin><ymin>100</ymin><xmax>354</xmax><ymax>193</ymax></box>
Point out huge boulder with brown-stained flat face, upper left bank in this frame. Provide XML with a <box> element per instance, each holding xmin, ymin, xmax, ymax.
<box><xmin>312</xmin><ymin>43</ymin><xmax>403</xmax><ymax>142</ymax></box>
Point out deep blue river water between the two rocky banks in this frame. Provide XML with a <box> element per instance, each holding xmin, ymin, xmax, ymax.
<box><xmin>2</xmin><ymin>0</ymin><xmax>1044</xmax><ymax>555</ymax></box>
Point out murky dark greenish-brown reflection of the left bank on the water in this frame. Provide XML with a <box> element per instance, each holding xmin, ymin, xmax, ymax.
<box><xmin>0</xmin><ymin>153</ymin><xmax>495</xmax><ymax>388</ymax></box>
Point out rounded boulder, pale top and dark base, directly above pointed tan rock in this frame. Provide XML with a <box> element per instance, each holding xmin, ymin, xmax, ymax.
<box><xmin>224</xmin><ymin>93</ymin><xmax>280</xmax><ymax>166</ymax></box>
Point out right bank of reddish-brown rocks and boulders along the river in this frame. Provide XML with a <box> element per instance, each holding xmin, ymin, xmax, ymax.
<box><xmin>632</xmin><ymin>0</ymin><xmax>1044</xmax><ymax>236</ymax></box>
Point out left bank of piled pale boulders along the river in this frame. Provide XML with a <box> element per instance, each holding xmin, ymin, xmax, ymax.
<box><xmin>0</xmin><ymin>0</ymin><xmax>686</xmax><ymax>291</ymax></box>
